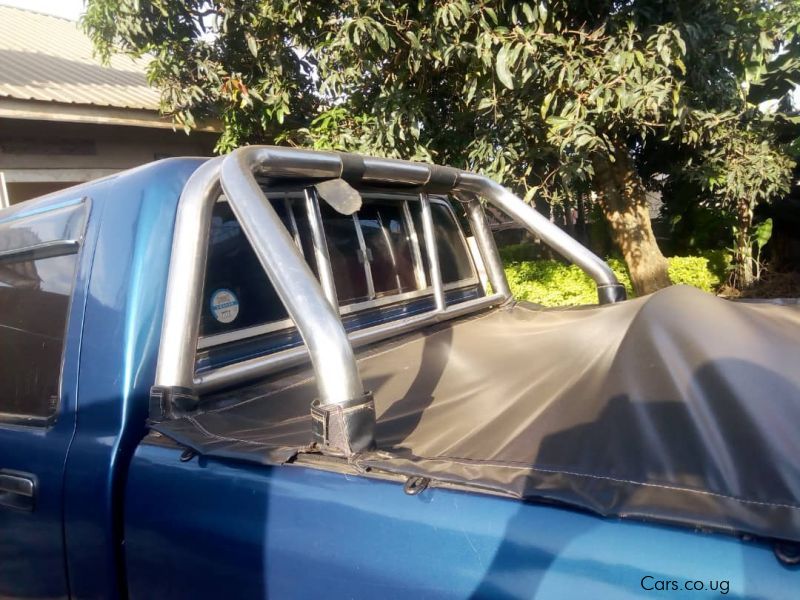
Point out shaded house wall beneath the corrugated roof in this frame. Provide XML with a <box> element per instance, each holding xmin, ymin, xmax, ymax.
<box><xmin>0</xmin><ymin>119</ymin><xmax>217</xmax><ymax>206</ymax></box>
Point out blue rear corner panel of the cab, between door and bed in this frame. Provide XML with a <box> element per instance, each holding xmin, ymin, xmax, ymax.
<box><xmin>64</xmin><ymin>159</ymin><xmax>202</xmax><ymax>598</ymax></box>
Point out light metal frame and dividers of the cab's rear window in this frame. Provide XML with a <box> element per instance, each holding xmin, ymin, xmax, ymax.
<box><xmin>197</xmin><ymin>184</ymin><xmax>478</xmax><ymax>351</ymax></box>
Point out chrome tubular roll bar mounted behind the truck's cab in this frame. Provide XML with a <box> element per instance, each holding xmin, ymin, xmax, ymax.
<box><xmin>153</xmin><ymin>146</ymin><xmax>625</xmax><ymax>450</ymax></box>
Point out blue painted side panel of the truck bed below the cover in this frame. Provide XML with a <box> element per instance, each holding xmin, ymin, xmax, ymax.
<box><xmin>125</xmin><ymin>444</ymin><xmax>800</xmax><ymax>599</ymax></box>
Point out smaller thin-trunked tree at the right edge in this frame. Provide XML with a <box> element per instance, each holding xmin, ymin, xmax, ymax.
<box><xmin>648</xmin><ymin>2</ymin><xmax>800</xmax><ymax>288</ymax></box>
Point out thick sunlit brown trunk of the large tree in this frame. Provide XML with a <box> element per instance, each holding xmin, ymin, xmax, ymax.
<box><xmin>593</xmin><ymin>148</ymin><xmax>672</xmax><ymax>296</ymax></box>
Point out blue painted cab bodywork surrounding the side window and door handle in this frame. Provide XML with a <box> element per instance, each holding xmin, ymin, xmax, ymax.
<box><xmin>0</xmin><ymin>159</ymin><xmax>203</xmax><ymax>598</ymax></box>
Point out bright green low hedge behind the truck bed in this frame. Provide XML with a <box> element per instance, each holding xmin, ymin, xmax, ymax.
<box><xmin>504</xmin><ymin>252</ymin><xmax>728</xmax><ymax>306</ymax></box>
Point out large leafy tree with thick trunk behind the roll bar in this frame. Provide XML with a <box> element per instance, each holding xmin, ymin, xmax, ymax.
<box><xmin>84</xmin><ymin>0</ymin><xmax>789</xmax><ymax>294</ymax></box>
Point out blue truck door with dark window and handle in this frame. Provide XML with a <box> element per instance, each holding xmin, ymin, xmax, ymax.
<box><xmin>0</xmin><ymin>199</ymin><xmax>86</xmax><ymax>599</ymax></box>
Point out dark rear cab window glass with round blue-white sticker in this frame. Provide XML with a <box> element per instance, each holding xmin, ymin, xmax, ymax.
<box><xmin>200</xmin><ymin>188</ymin><xmax>477</xmax><ymax>348</ymax></box>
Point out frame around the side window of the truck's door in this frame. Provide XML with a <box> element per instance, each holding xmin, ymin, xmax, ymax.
<box><xmin>0</xmin><ymin>197</ymin><xmax>90</xmax><ymax>430</ymax></box>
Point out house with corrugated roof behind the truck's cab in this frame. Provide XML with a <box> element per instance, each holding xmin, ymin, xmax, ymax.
<box><xmin>0</xmin><ymin>6</ymin><xmax>217</xmax><ymax>207</ymax></box>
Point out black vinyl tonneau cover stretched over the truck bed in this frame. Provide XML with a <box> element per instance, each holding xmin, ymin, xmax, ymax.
<box><xmin>154</xmin><ymin>287</ymin><xmax>800</xmax><ymax>541</ymax></box>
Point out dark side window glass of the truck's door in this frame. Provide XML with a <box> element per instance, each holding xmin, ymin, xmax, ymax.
<box><xmin>0</xmin><ymin>206</ymin><xmax>85</xmax><ymax>424</ymax></box>
